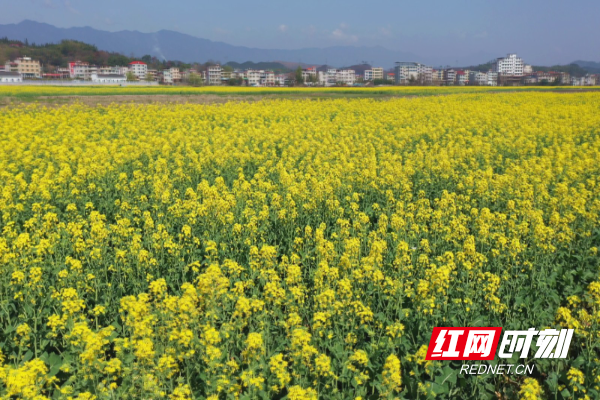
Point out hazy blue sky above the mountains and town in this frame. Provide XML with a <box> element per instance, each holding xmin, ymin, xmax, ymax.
<box><xmin>0</xmin><ymin>0</ymin><xmax>600</xmax><ymax>65</ymax></box>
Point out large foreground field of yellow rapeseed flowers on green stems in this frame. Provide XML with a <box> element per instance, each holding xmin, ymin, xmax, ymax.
<box><xmin>0</xmin><ymin>89</ymin><xmax>600</xmax><ymax>400</ymax></box>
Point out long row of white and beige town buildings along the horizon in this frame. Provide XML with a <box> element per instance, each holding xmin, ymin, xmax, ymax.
<box><xmin>0</xmin><ymin>54</ymin><xmax>600</xmax><ymax>86</ymax></box>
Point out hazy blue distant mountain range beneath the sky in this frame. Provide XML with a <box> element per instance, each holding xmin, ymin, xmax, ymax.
<box><xmin>0</xmin><ymin>20</ymin><xmax>424</xmax><ymax>67</ymax></box>
